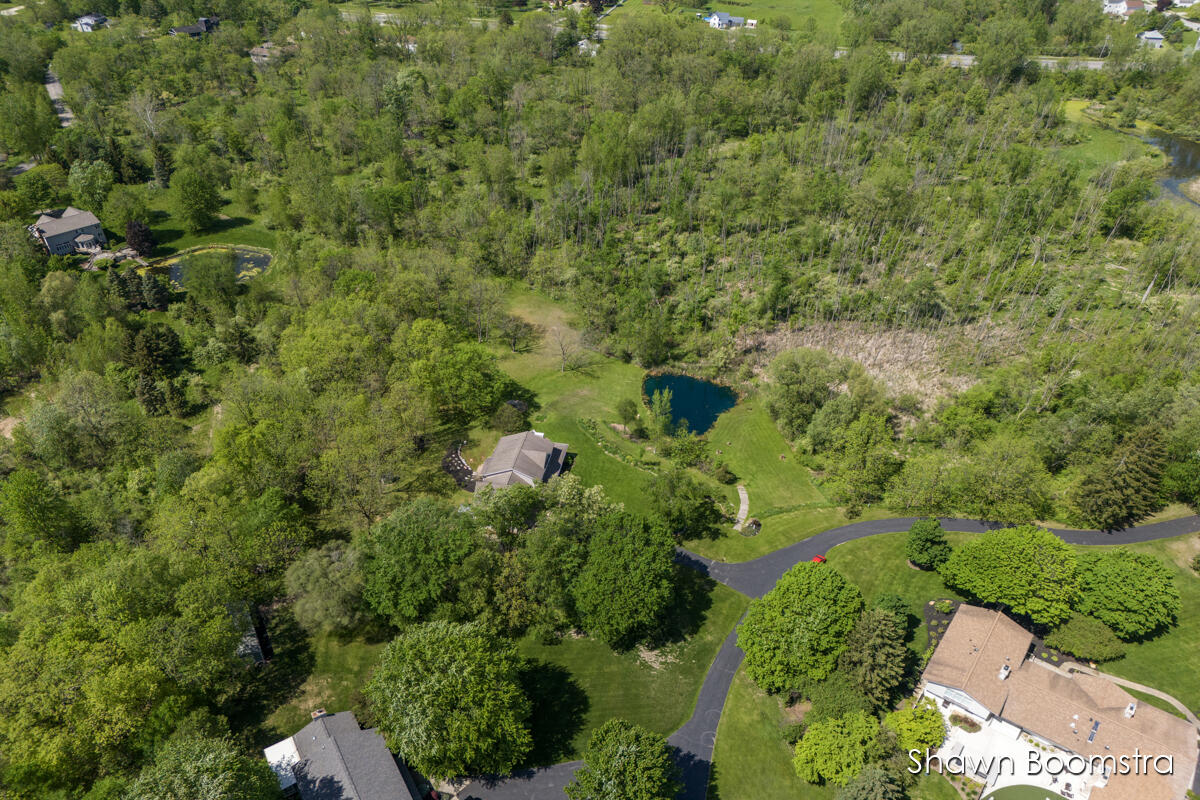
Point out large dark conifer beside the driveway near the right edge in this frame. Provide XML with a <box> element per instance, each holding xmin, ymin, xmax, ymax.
<box><xmin>1073</xmin><ymin>426</ymin><xmax>1166</xmax><ymax>530</ymax></box>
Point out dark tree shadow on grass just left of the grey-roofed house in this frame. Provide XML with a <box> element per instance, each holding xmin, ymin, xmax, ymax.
<box><xmin>220</xmin><ymin>609</ymin><xmax>316</xmax><ymax>747</ymax></box>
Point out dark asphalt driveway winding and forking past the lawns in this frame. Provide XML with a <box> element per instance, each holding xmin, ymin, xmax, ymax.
<box><xmin>460</xmin><ymin>517</ymin><xmax>1200</xmax><ymax>800</ymax></box>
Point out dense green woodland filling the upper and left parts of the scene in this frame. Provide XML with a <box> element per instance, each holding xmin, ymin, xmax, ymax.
<box><xmin>0</xmin><ymin>0</ymin><xmax>1200</xmax><ymax>800</ymax></box>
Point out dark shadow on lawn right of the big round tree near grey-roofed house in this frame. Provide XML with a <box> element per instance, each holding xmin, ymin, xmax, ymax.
<box><xmin>521</xmin><ymin>661</ymin><xmax>592</xmax><ymax>766</ymax></box>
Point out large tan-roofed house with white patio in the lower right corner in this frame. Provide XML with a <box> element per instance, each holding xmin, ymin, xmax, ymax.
<box><xmin>922</xmin><ymin>604</ymin><xmax>1196</xmax><ymax>800</ymax></box>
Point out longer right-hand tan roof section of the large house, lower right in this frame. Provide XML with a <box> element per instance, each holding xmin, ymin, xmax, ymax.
<box><xmin>1001</xmin><ymin>660</ymin><xmax>1196</xmax><ymax>800</ymax></box>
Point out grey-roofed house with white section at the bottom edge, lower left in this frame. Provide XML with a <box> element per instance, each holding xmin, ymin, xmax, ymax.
<box><xmin>263</xmin><ymin>710</ymin><xmax>418</xmax><ymax>800</ymax></box>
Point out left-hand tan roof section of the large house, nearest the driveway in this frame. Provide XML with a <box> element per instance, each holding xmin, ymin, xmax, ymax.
<box><xmin>925</xmin><ymin>604</ymin><xmax>1033</xmax><ymax>715</ymax></box>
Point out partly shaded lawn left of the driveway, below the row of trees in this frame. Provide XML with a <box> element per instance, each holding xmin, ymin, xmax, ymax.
<box><xmin>518</xmin><ymin>567</ymin><xmax>749</xmax><ymax>764</ymax></box>
